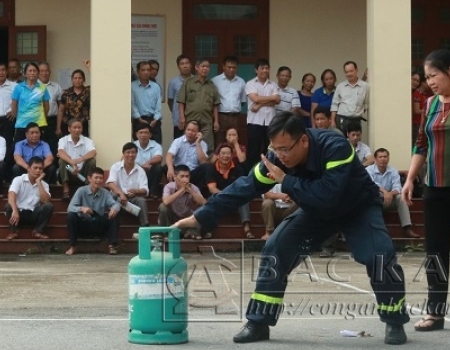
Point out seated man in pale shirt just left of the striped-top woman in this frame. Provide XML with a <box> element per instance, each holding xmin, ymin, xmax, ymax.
<box><xmin>366</xmin><ymin>148</ymin><xmax>420</xmax><ymax>238</ymax></box>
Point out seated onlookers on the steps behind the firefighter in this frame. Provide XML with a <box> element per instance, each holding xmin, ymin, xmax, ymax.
<box><xmin>0</xmin><ymin>116</ymin><xmax>418</xmax><ymax>256</ymax></box>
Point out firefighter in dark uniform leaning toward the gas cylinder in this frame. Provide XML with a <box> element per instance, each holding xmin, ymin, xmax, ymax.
<box><xmin>175</xmin><ymin>112</ymin><xmax>409</xmax><ymax>344</ymax></box>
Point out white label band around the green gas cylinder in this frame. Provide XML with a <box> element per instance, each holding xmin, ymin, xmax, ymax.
<box><xmin>128</xmin><ymin>274</ymin><xmax>184</xmax><ymax>300</ymax></box>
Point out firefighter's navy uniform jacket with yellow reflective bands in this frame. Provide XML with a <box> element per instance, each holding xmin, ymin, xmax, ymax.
<box><xmin>194</xmin><ymin>129</ymin><xmax>382</xmax><ymax>230</ymax></box>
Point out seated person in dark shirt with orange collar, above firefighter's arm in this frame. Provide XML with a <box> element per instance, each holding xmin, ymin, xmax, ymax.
<box><xmin>205</xmin><ymin>143</ymin><xmax>255</xmax><ymax>239</ymax></box>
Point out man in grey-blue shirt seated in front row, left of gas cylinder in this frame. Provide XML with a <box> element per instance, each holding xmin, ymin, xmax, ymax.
<box><xmin>66</xmin><ymin>167</ymin><xmax>120</xmax><ymax>255</ymax></box>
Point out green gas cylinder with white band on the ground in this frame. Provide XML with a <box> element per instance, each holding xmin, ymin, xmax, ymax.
<box><xmin>128</xmin><ymin>227</ymin><xmax>188</xmax><ymax>344</ymax></box>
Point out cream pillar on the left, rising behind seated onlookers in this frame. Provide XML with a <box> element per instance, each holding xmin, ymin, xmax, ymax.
<box><xmin>90</xmin><ymin>0</ymin><xmax>131</xmax><ymax>170</ymax></box>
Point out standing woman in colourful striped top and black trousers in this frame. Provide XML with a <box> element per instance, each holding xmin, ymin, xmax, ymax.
<box><xmin>402</xmin><ymin>50</ymin><xmax>450</xmax><ymax>332</ymax></box>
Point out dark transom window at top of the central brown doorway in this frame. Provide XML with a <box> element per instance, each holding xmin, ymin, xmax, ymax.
<box><xmin>194</xmin><ymin>4</ymin><xmax>258</xmax><ymax>20</ymax></box>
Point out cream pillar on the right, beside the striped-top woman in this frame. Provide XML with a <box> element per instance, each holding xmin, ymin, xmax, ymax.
<box><xmin>367</xmin><ymin>0</ymin><xmax>411</xmax><ymax>170</ymax></box>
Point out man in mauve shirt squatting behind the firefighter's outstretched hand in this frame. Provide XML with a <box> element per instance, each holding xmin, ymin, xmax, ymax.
<box><xmin>158</xmin><ymin>164</ymin><xmax>206</xmax><ymax>239</ymax></box>
